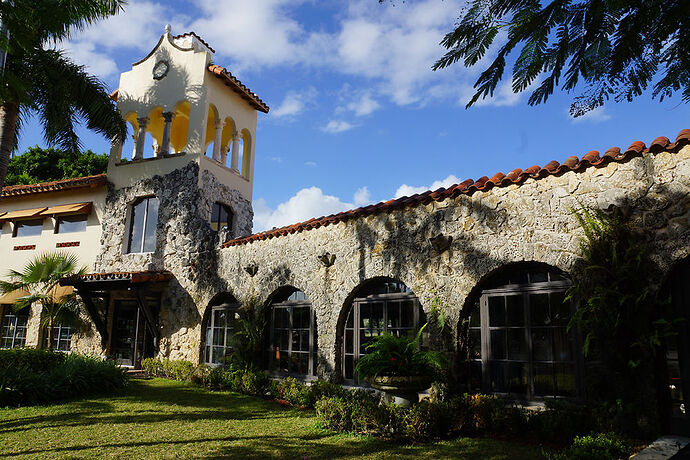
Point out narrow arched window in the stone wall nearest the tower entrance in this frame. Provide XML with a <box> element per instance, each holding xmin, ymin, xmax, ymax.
<box><xmin>204</xmin><ymin>294</ymin><xmax>240</xmax><ymax>365</ymax></box>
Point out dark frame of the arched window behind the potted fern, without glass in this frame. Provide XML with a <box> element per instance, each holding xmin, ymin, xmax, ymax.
<box><xmin>340</xmin><ymin>292</ymin><xmax>425</xmax><ymax>385</ymax></box>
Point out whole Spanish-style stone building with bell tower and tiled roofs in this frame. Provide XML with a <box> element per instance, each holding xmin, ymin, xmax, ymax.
<box><xmin>0</xmin><ymin>30</ymin><xmax>690</xmax><ymax>428</ymax></box>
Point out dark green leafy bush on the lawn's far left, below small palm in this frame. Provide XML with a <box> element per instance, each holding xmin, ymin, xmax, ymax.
<box><xmin>0</xmin><ymin>352</ymin><xmax>127</xmax><ymax>407</ymax></box>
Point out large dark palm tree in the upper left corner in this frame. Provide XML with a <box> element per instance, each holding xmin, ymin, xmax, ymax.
<box><xmin>0</xmin><ymin>0</ymin><xmax>126</xmax><ymax>188</ymax></box>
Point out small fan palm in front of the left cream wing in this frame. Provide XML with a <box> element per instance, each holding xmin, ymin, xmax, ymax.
<box><xmin>0</xmin><ymin>253</ymin><xmax>86</xmax><ymax>350</ymax></box>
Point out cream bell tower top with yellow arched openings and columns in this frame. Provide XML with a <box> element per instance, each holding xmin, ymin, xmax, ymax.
<box><xmin>108</xmin><ymin>25</ymin><xmax>269</xmax><ymax>203</ymax></box>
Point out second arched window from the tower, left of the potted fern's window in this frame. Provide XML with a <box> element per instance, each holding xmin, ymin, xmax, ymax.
<box><xmin>268</xmin><ymin>288</ymin><xmax>318</xmax><ymax>377</ymax></box>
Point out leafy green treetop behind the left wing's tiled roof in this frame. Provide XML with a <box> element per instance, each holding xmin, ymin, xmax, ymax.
<box><xmin>5</xmin><ymin>146</ymin><xmax>108</xmax><ymax>185</ymax></box>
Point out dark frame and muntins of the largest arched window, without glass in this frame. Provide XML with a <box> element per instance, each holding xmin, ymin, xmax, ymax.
<box><xmin>466</xmin><ymin>269</ymin><xmax>584</xmax><ymax>402</ymax></box>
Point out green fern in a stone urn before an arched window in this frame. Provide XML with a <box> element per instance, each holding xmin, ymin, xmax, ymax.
<box><xmin>355</xmin><ymin>324</ymin><xmax>446</xmax><ymax>405</ymax></box>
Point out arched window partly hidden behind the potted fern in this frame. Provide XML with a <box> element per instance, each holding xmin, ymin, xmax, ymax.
<box><xmin>342</xmin><ymin>278</ymin><xmax>425</xmax><ymax>383</ymax></box>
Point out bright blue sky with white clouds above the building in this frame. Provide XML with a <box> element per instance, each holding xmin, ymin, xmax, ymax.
<box><xmin>20</xmin><ymin>0</ymin><xmax>690</xmax><ymax>231</ymax></box>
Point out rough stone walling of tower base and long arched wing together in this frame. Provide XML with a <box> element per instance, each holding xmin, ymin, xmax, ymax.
<box><xmin>75</xmin><ymin>146</ymin><xmax>690</xmax><ymax>378</ymax></box>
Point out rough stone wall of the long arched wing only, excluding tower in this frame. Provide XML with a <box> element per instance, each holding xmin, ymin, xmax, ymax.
<box><xmin>215</xmin><ymin>146</ymin><xmax>690</xmax><ymax>376</ymax></box>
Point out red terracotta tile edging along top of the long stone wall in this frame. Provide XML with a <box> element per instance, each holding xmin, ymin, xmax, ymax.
<box><xmin>222</xmin><ymin>129</ymin><xmax>690</xmax><ymax>247</ymax></box>
